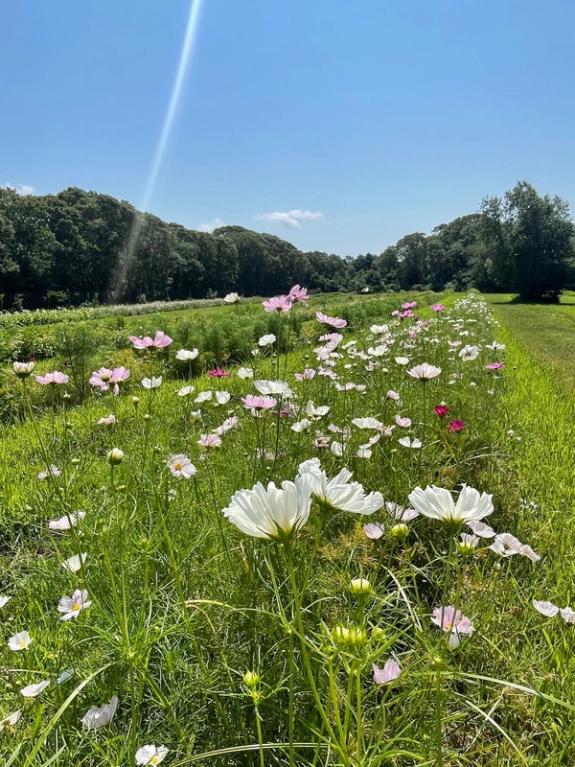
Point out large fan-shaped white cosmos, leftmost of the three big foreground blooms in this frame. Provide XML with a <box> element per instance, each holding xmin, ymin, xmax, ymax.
<box><xmin>222</xmin><ymin>477</ymin><xmax>311</xmax><ymax>539</ymax></box>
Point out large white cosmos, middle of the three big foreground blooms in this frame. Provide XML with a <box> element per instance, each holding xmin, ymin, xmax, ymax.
<box><xmin>298</xmin><ymin>458</ymin><xmax>383</xmax><ymax>514</ymax></box>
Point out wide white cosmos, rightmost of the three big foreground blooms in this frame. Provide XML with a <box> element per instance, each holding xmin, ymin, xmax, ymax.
<box><xmin>409</xmin><ymin>485</ymin><xmax>493</xmax><ymax>523</ymax></box>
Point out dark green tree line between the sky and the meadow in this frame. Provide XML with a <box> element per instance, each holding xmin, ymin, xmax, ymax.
<box><xmin>0</xmin><ymin>182</ymin><xmax>575</xmax><ymax>310</ymax></box>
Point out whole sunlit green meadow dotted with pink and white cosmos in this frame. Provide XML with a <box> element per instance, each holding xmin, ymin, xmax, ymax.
<box><xmin>0</xmin><ymin>290</ymin><xmax>575</xmax><ymax>767</ymax></box>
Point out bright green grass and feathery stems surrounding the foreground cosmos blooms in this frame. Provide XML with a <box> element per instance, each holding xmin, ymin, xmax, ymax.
<box><xmin>0</xmin><ymin>296</ymin><xmax>575</xmax><ymax>767</ymax></box>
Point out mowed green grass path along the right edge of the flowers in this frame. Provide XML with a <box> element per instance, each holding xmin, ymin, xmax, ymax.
<box><xmin>480</xmin><ymin>296</ymin><xmax>575</xmax><ymax>767</ymax></box>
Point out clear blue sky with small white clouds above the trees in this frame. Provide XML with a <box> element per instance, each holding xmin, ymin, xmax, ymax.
<box><xmin>0</xmin><ymin>0</ymin><xmax>575</xmax><ymax>255</ymax></box>
